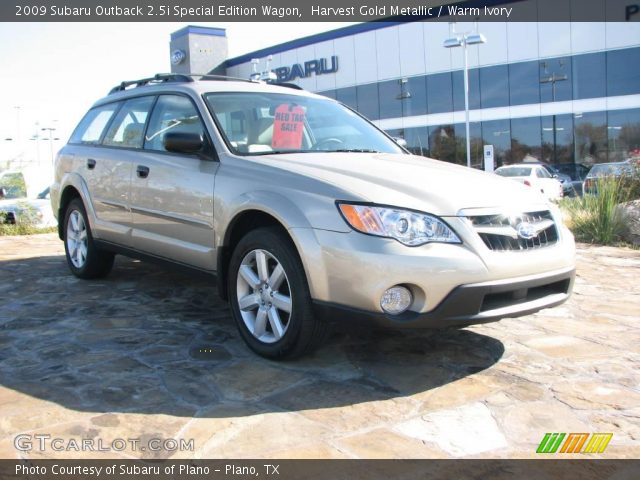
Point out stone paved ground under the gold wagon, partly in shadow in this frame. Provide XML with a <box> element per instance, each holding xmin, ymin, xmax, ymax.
<box><xmin>0</xmin><ymin>234</ymin><xmax>640</xmax><ymax>458</ymax></box>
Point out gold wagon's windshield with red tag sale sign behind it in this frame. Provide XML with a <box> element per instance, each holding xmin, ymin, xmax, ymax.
<box><xmin>205</xmin><ymin>92</ymin><xmax>404</xmax><ymax>155</ymax></box>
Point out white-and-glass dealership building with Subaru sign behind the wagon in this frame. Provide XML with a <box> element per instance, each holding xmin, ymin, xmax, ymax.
<box><xmin>171</xmin><ymin>10</ymin><xmax>640</xmax><ymax>168</ymax></box>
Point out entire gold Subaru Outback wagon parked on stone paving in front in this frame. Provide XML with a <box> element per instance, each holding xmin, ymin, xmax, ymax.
<box><xmin>51</xmin><ymin>74</ymin><xmax>575</xmax><ymax>358</ymax></box>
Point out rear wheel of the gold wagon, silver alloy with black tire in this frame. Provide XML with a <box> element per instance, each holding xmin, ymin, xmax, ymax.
<box><xmin>63</xmin><ymin>198</ymin><xmax>115</xmax><ymax>279</ymax></box>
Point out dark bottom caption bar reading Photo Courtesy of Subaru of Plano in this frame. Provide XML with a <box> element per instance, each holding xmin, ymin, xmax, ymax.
<box><xmin>0</xmin><ymin>457</ymin><xmax>640</xmax><ymax>480</ymax></box>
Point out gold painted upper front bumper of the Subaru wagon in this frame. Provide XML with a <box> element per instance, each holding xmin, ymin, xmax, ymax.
<box><xmin>290</xmin><ymin>218</ymin><xmax>575</xmax><ymax>314</ymax></box>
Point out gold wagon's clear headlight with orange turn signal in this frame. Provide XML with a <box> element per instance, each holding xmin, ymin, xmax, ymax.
<box><xmin>338</xmin><ymin>203</ymin><xmax>462</xmax><ymax>247</ymax></box>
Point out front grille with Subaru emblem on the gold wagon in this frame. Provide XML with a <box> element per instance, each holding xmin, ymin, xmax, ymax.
<box><xmin>467</xmin><ymin>210</ymin><xmax>558</xmax><ymax>252</ymax></box>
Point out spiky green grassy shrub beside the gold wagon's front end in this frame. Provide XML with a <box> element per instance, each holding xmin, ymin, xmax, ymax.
<box><xmin>560</xmin><ymin>177</ymin><xmax>631</xmax><ymax>245</ymax></box>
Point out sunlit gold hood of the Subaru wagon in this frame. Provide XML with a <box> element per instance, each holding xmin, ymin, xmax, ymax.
<box><xmin>255</xmin><ymin>152</ymin><xmax>546</xmax><ymax>216</ymax></box>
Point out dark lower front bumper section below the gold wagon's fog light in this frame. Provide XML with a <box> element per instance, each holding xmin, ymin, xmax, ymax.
<box><xmin>313</xmin><ymin>268</ymin><xmax>575</xmax><ymax>328</ymax></box>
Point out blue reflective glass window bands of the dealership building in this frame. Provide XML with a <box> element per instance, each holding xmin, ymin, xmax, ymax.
<box><xmin>319</xmin><ymin>48</ymin><xmax>640</xmax><ymax>167</ymax></box>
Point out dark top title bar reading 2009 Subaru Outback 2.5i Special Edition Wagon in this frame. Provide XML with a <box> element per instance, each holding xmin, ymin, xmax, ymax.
<box><xmin>0</xmin><ymin>0</ymin><xmax>640</xmax><ymax>22</ymax></box>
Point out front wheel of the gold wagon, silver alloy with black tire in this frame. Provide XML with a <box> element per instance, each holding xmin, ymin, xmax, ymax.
<box><xmin>227</xmin><ymin>228</ymin><xmax>328</xmax><ymax>359</ymax></box>
